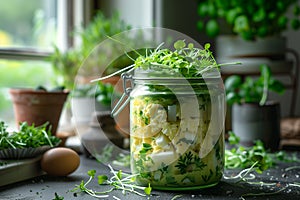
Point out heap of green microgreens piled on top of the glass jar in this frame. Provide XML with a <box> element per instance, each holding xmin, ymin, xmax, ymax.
<box><xmin>91</xmin><ymin>37</ymin><xmax>240</xmax><ymax>82</ymax></box>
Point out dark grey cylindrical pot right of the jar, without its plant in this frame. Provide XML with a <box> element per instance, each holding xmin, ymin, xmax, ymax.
<box><xmin>232</xmin><ymin>102</ymin><xmax>280</xmax><ymax>150</ymax></box>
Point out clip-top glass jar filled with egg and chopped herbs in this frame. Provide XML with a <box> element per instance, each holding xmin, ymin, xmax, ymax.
<box><xmin>129</xmin><ymin>69</ymin><xmax>225</xmax><ymax>190</ymax></box>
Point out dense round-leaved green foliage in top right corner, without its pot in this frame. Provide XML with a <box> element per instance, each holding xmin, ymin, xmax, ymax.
<box><xmin>198</xmin><ymin>0</ymin><xmax>300</xmax><ymax>40</ymax></box>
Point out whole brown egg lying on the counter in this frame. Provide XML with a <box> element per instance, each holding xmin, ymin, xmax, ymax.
<box><xmin>41</xmin><ymin>147</ymin><xmax>80</xmax><ymax>176</ymax></box>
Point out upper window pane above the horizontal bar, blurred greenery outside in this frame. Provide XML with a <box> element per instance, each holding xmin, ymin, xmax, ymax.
<box><xmin>0</xmin><ymin>0</ymin><xmax>57</xmax><ymax>50</ymax></box>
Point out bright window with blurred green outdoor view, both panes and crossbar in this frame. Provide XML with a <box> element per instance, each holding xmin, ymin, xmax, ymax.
<box><xmin>0</xmin><ymin>0</ymin><xmax>58</xmax><ymax>123</ymax></box>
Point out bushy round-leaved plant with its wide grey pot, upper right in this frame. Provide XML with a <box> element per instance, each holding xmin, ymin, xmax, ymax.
<box><xmin>197</xmin><ymin>0</ymin><xmax>300</xmax><ymax>75</ymax></box>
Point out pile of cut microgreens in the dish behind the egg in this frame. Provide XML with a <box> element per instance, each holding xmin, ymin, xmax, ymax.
<box><xmin>0</xmin><ymin>121</ymin><xmax>61</xmax><ymax>150</ymax></box>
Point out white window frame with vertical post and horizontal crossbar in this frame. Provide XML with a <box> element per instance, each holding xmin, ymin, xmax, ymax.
<box><xmin>0</xmin><ymin>0</ymin><xmax>90</xmax><ymax>61</ymax></box>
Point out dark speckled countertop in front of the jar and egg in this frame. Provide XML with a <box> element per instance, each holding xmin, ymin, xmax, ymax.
<box><xmin>0</xmin><ymin>152</ymin><xmax>300</xmax><ymax>200</ymax></box>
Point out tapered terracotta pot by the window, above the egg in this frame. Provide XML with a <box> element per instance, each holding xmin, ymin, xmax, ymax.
<box><xmin>9</xmin><ymin>89</ymin><xmax>69</xmax><ymax>135</ymax></box>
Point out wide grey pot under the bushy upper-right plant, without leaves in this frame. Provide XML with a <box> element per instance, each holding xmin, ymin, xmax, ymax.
<box><xmin>216</xmin><ymin>35</ymin><xmax>293</xmax><ymax>75</ymax></box>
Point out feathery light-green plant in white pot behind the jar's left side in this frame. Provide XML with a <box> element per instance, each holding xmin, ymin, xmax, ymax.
<box><xmin>49</xmin><ymin>11</ymin><xmax>132</xmax><ymax>124</ymax></box>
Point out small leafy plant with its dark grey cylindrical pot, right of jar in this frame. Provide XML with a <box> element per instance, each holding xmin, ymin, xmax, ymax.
<box><xmin>225</xmin><ymin>65</ymin><xmax>285</xmax><ymax>149</ymax></box>
